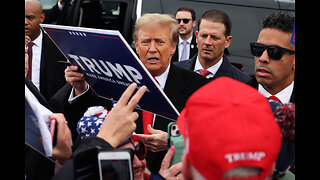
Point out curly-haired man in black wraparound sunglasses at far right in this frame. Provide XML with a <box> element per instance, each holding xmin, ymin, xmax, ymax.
<box><xmin>248</xmin><ymin>13</ymin><xmax>295</xmax><ymax>103</ymax></box>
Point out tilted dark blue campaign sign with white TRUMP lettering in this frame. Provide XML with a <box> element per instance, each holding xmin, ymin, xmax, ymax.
<box><xmin>41</xmin><ymin>24</ymin><xmax>179</xmax><ymax>120</ymax></box>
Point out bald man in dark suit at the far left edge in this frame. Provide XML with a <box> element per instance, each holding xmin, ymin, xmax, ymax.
<box><xmin>25</xmin><ymin>0</ymin><xmax>66</xmax><ymax>100</ymax></box>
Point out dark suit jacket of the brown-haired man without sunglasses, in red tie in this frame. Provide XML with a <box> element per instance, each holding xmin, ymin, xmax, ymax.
<box><xmin>174</xmin><ymin>55</ymin><xmax>251</xmax><ymax>83</ymax></box>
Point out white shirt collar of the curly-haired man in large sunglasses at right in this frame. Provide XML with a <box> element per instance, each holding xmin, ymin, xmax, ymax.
<box><xmin>258</xmin><ymin>81</ymin><xmax>294</xmax><ymax>104</ymax></box>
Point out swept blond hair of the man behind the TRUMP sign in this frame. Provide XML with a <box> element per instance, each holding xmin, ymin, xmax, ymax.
<box><xmin>133</xmin><ymin>13</ymin><xmax>179</xmax><ymax>45</ymax></box>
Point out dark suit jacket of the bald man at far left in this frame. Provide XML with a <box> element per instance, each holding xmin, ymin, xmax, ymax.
<box><xmin>40</xmin><ymin>32</ymin><xmax>66</xmax><ymax>100</ymax></box>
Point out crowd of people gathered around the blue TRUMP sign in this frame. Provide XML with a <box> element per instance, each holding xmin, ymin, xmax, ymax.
<box><xmin>25</xmin><ymin>0</ymin><xmax>295</xmax><ymax>180</ymax></box>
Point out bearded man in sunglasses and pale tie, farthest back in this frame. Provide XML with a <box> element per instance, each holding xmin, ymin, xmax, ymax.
<box><xmin>171</xmin><ymin>6</ymin><xmax>198</xmax><ymax>62</ymax></box>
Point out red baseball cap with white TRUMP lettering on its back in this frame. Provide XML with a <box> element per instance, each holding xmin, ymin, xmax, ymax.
<box><xmin>177</xmin><ymin>77</ymin><xmax>282</xmax><ymax>179</ymax></box>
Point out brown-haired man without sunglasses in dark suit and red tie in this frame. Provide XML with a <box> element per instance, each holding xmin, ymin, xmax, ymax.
<box><xmin>175</xmin><ymin>9</ymin><xmax>250</xmax><ymax>83</ymax></box>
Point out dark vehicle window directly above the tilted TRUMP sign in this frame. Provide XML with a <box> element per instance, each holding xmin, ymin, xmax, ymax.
<box><xmin>80</xmin><ymin>0</ymin><xmax>127</xmax><ymax>32</ymax></box>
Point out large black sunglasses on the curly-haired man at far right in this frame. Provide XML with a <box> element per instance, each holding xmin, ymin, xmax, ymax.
<box><xmin>250</xmin><ymin>43</ymin><xmax>296</xmax><ymax>60</ymax></box>
